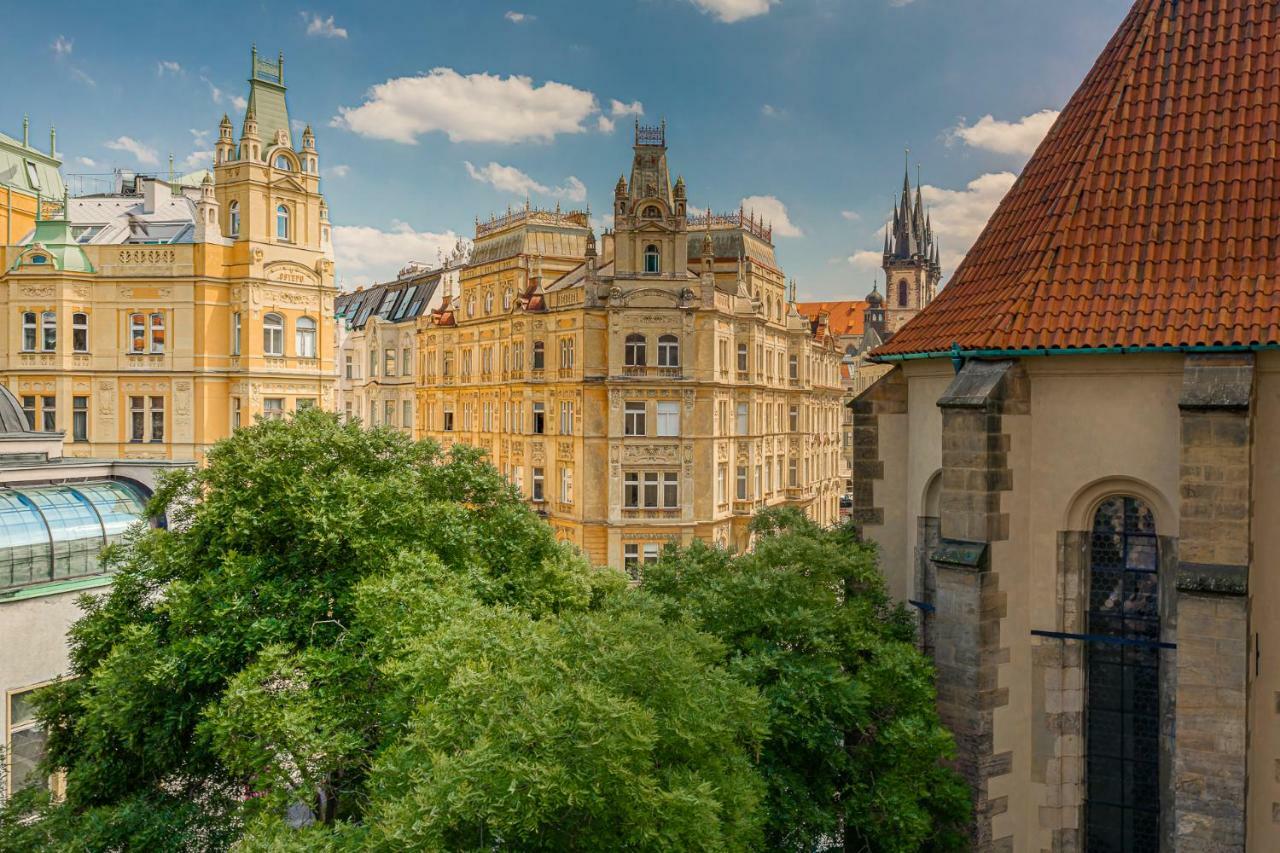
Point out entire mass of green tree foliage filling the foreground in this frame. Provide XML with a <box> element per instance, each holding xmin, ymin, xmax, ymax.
<box><xmin>0</xmin><ymin>411</ymin><xmax>963</xmax><ymax>853</ymax></box>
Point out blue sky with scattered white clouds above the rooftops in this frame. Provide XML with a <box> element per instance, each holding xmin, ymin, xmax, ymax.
<box><xmin>10</xmin><ymin>0</ymin><xmax>1129</xmax><ymax>298</ymax></box>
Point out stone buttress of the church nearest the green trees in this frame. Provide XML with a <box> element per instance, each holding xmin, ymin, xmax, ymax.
<box><xmin>931</xmin><ymin>360</ymin><xmax>1030</xmax><ymax>850</ymax></box>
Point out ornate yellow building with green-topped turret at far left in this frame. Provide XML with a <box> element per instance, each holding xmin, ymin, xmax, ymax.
<box><xmin>0</xmin><ymin>50</ymin><xmax>335</xmax><ymax>460</ymax></box>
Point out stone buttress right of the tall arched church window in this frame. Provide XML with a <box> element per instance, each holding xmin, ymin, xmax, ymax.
<box><xmin>1172</xmin><ymin>352</ymin><xmax>1253</xmax><ymax>853</ymax></box>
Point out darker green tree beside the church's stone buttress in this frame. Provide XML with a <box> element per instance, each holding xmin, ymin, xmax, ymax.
<box><xmin>644</xmin><ymin>510</ymin><xmax>969</xmax><ymax>852</ymax></box>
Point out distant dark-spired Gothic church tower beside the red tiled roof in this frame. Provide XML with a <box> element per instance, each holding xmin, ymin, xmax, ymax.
<box><xmin>883</xmin><ymin>156</ymin><xmax>942</xmax><ymax>334</ymax></box>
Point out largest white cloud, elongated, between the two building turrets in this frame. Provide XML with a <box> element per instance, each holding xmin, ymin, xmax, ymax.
<box><xmin>330</xmin><ymin>68</ymin><xmax>596</xmax><ymax>145</ymax></box>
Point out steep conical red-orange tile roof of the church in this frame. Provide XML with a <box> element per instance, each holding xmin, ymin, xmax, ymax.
<box><xmin>874</xmin><ymin>0</ymin><xmax>1280</xmax><ymax>355</ymax></box>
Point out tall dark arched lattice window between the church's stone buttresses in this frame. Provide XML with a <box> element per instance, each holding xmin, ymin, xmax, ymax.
<box><xmin>1084</xmin><ymin>496</ymin><xmax>1162</xmax><ymax>850</ymax></box>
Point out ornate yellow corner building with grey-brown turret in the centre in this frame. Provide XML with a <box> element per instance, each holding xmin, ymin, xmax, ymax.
<box><xmin>417</xmin><ymin>126</ymin><xmax>842</xmax><ymax>571</ymax></box>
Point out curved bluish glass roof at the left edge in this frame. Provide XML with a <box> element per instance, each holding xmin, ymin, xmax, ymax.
<box><xmin>0</xmin><ymin>480</ymin><xmax>143</xmax><ymax>589</ymax></box>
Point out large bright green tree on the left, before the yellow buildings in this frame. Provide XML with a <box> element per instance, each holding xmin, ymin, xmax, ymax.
<box><xmin>0</xmin><ymin>411</ymin><xmax>765</xmax><ymax>852</ymax></box>
